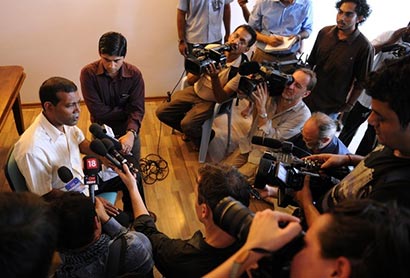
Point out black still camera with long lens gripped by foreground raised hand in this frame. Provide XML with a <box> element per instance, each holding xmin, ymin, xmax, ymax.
<box><xmin>213</xmin><ymin>197</ymin><xmax>304</xmax><ymax>277</ymax></box>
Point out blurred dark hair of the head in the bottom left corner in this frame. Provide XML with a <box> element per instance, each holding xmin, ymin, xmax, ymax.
<box><xmin>0</xmin><ymin>192</ymin><xmax>57</xmax><ymax>277</ymax></box>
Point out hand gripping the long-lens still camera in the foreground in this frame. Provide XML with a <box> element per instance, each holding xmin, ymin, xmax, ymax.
<box><xmin>244</xmin><ymin>209</ymin><xmax>302</xmax><ymax>251</ymax></box>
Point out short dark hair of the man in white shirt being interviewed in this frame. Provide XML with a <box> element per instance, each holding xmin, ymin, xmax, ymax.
<box><xmin>39</xmin><ymin>77</ymin><xmax>77</xmax><ymax>108</ymax></box>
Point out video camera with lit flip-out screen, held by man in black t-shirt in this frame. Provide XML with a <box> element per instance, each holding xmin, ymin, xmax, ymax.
<box><xmin>252</xmin><ymin>136</ymin><xmax>349</xmax><ymax>207</ymax></box>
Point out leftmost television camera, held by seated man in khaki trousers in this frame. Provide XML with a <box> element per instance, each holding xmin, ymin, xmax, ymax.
<box><xmin>185</xmin><ymin>44</ymin><xmax>232</xmax><ymax>75</ymax></box>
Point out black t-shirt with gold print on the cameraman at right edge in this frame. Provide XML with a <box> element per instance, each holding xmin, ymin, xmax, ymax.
<box><xmin>322</xmin><ymin>146</ymin><xmax>410</xmax><ymax>210</ymax></box>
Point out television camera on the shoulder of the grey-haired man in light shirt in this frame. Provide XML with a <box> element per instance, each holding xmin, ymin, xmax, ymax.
<box><xmin>238</xmin><ymin>60</ymin><xmax>299</xmax><ymax>96</ymax></box>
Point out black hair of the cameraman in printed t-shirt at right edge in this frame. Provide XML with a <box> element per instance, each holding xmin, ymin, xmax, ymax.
<box><xmin>365</xmin><ymin>55</ymin><xmax>410</xmax><ymax>128</ymax></box>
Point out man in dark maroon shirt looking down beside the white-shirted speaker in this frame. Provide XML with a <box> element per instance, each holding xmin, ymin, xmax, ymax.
<box><xmin>80</xmin><ymin>32</ymin><xmax>145</xmax><ymax>165</ymax></box>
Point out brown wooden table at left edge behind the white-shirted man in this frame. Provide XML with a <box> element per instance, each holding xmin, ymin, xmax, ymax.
<box><xmin>0</xmin><ymin>66</ymin><xmax>26</xmax><ymax>135</ymax></box>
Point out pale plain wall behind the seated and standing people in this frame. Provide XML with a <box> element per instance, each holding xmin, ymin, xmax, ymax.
<box><xmin>0</xmin><ymin>0</ymin><xmax>410</xmax><ymax>103</ymax></box>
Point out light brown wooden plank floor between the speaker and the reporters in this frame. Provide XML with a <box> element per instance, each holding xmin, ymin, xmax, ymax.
<box><xmin>0</xmin><ymin>101</ymin><xmax>272</xmax><ymax>238</ymax></box>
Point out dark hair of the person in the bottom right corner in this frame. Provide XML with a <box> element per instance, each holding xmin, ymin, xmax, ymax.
<box><xmin>319</xmin><ymin>199</ymin><xmax>410</xmax><ymax>278</ymax></box>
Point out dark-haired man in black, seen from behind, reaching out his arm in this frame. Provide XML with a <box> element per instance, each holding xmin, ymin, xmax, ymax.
<box><xmin>116</xmin><ymin>164</ymin><xmax>249</xmax><ymax>278</ymax></box>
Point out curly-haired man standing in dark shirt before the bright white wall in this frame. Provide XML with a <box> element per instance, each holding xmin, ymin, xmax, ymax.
<box><xmin>304</xmin><ymin>0</ymin><xmax>374</xmax><ymax>119</ymax></box>
